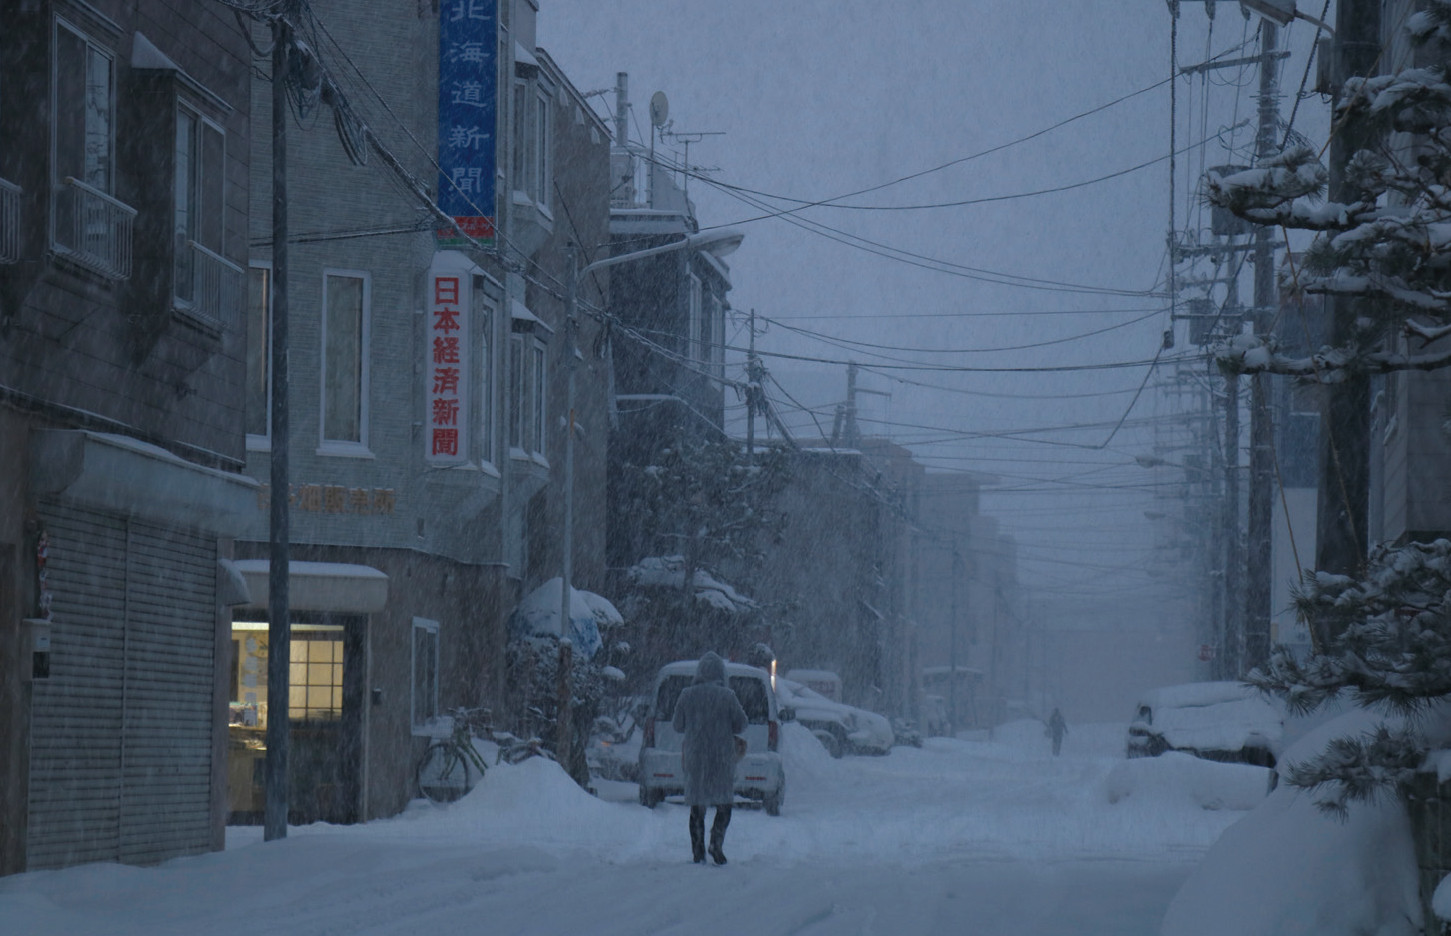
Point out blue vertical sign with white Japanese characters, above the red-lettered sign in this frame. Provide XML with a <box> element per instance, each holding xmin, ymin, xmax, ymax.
<box><xmin>438</xmin><ymin>0</ymin><xmax>499</xmax><ymax>245</ymax></box>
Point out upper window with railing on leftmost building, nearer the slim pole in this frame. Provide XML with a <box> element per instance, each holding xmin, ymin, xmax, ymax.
<box><xmin>173</xmin><ymin>107</ymin><xmax>229</xmax><ymax>324</ymax></box>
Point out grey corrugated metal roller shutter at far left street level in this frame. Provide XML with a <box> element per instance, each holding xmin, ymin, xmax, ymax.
<box><xmin>26</xmin><ymin>505</ymin><xmax>216</xmax><ymax>869</ymax></box>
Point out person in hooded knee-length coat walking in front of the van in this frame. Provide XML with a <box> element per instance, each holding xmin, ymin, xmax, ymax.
<box><xmin>672</xmin><ymin>653</ymin><xmax>746</xmax><ymax>865</ymax></box>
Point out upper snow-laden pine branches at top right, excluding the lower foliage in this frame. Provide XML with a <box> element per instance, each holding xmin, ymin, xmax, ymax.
<box><xmin>1206</xmin><ymin>0</ymin><xmax>1451</xmax><ymax>383</ymax></box>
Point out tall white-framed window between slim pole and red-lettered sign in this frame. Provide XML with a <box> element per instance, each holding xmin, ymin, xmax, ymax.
<box><xmin>322</xmin><ymin>273</ymin><xmax>369</xmax><ymax>454</ymax></box>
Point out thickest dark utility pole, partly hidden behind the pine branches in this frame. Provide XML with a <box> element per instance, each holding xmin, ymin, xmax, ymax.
<box><xmin>1310</xmin><ymin>0</ymin><xmax>1381</xmax><ymax>647</ymax></box>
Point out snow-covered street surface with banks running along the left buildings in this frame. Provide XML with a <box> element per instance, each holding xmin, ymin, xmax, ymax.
<box><xmin>0</xmin><ymin>726</ymin><xmax>1259</xmax><ymax>936</ymax></box>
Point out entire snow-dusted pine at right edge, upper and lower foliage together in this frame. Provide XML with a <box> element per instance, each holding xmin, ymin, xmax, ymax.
<box><xmin>1206</xmin><ymin>0</ymin><xmax>1451</xmax><ymax>814</ymax></box>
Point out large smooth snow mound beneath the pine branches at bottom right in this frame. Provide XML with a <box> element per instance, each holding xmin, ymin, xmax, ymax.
<box><xmin>1161</xmin><ymin>710</ymin><xmax>1421</xmax><ymax>936</ymax></box>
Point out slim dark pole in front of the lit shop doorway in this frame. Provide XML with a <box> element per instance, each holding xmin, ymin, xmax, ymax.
<box><xmin>263</xmin><ymin>3</ymin><xmax>293</xmax><ymax>842</ymax></box>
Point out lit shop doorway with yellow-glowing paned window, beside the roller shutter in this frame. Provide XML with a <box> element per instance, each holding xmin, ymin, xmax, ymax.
<box><xmin>226</xmin><ymin>609</ymin><xmax>367</xmax><ymax>824</ymax></box>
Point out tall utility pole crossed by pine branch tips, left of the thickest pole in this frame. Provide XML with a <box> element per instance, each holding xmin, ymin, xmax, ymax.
<box><xmin>1230</xmin><ymin>19</ymin><xmax>1280</xmax><ymax>676</ymax></box>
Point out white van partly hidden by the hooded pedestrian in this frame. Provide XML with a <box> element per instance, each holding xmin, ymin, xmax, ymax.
<box><xmin>640</xmin><ymin>660</ymin><xmax>786</xmax><ymax>816</ymax></box>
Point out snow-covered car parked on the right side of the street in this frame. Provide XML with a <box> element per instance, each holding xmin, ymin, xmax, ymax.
<box><xmin>1127</xmin><ymin>681</ymin><xmax>1284</xmax><ymax>768</ymax></box>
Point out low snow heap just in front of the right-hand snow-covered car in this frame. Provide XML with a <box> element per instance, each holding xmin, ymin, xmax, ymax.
<box><xmin>1103</xmin><ymin>750</ymin><xmax>1274</xmax><ymax>810</ymax></box>
